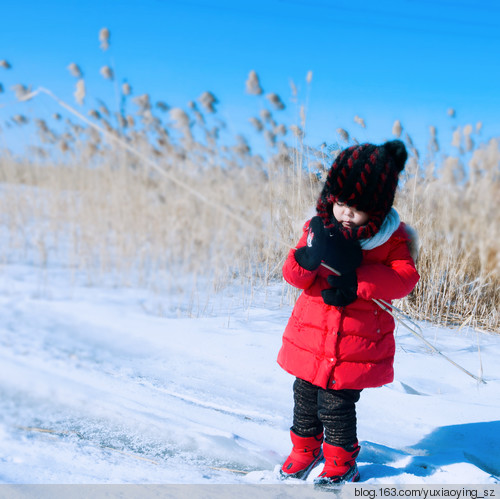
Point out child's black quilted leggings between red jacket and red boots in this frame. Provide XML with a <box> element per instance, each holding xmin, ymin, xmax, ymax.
<box><xmin>292</xmin><ymin>378</ymin><xmax>361</xmax><ymax>447</ymax></box>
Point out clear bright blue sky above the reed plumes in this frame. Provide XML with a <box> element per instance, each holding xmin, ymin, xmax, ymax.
<box><xmin>0</xmin><ymin>0</ymin><xmax>500</xmax><ymax>158</ymax></box>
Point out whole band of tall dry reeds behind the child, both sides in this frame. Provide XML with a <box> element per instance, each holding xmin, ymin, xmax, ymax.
<box><xmin>0</xmin><ymin>33</ymin><xmax>500</xmax><ymax>331</ymax></box>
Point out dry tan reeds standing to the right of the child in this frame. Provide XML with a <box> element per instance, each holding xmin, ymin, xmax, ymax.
<box><xmin>397</xmin><ymin>139</ymin><xmax>500</xmax><ymax>332</ymax></box>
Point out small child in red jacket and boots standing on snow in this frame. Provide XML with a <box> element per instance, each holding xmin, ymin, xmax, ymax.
<box><xmin>278</xmin><ymin>140</ymin><xmax>419</xmax><ymax>486</ymax></box>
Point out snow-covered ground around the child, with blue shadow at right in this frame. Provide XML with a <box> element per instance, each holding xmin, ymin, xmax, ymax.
<box><xmin>0</xmin><ymin>263</ymin><xmax>500</xmax><ymax>484</ymax></box>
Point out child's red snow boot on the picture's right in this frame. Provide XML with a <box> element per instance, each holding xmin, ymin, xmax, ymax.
<box><xmin>314</xmin><ymin>442</ymin><xmax>361</xmax><ymax>487</ymax></box>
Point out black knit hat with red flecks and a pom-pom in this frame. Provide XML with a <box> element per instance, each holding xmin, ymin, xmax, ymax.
<box><xmin>316</xmin><ymin>140</ymin><xmax>408</xmax><ymax>239</ymax></box>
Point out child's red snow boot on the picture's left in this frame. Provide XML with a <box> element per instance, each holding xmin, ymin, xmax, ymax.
<box><xmin>280</xmin><ymin>431</ymin><xmax>323</xmax><ymax>480</ymax></box>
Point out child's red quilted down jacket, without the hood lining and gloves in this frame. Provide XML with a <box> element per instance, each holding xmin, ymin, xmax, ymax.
<box><xmin>278</xmin><ymin>223</ymin><xmax>420</xmax><ymax>390</ymax></box>
